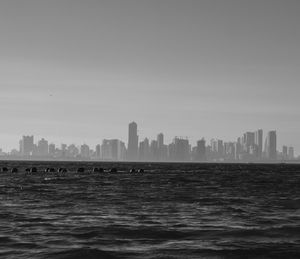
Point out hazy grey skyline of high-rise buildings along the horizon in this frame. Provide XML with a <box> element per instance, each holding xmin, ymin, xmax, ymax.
<box><xmin>0</xmin><ymin>122</ymin><xmax>295</xmax><ymax>162</ymax></box>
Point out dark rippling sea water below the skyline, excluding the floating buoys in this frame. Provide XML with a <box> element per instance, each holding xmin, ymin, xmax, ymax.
<box><xmin>0</xmin><ymin>162</ymin><xmax>300</xmax><ymax>259</ymax></box>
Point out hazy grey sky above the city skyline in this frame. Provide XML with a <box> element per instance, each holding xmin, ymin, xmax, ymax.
<box><xmin>0</xmin><ymin>0</ymin><xmax>300</xmax><ymax>154</ymax></box>
